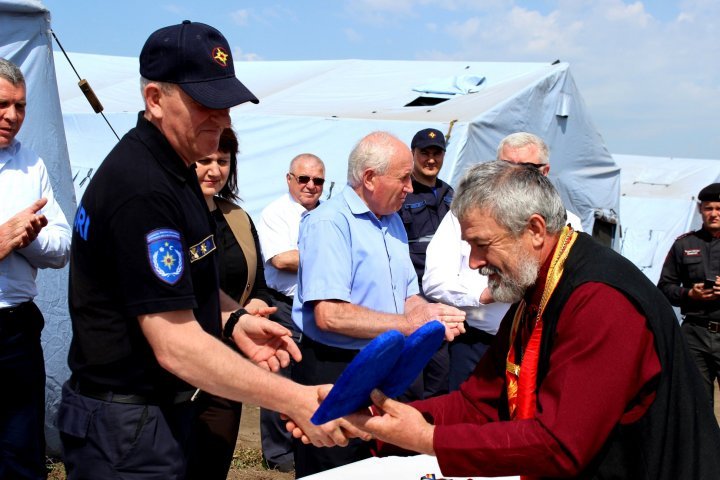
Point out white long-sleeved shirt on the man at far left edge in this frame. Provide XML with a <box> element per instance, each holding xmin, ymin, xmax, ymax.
<box><xmin>0</xmin><ymin>140</ymin><xmax>72</xmax><ymax>308</ymax></box>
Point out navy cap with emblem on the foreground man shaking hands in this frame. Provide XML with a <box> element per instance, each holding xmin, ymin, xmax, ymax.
<box><xmin>140</xmin><ymin>20</ymin><xmax>258</xmax><ymax>109</ymax></box>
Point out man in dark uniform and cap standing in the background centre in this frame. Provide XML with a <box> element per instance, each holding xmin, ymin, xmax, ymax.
<box><xmin>400</xmin><ymin>128</ymin><xmax>453</xmax><ymax>400</ymax></box>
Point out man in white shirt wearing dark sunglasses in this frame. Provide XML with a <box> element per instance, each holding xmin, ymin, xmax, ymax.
<box><xmin>258</xmin><ymin>153</ymin><xmax>325</xmax><ymax>471</ymax></box>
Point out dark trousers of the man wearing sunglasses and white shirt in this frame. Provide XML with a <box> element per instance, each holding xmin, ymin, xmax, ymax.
<box><xmin>260</xmin><ymin>293</ymin><xmax>299</xmax><ymax>470</ymax></box>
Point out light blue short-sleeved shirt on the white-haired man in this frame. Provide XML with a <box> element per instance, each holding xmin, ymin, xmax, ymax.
<box><xmin>292</xmin><ymin>186</ymin><xmax>418</xmax><ymax>349</ymax></box>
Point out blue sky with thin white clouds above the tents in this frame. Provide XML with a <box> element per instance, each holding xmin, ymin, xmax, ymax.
<box><xmin>43</xmin><ymin>0</ymin><xmax>720</xmax><ymax>159</ymax></box>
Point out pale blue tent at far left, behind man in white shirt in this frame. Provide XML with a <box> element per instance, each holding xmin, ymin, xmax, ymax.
<box><xmin>0</xmin><ymin>0</ymin><xmax>75</xmax><ymax>453</ymax></box>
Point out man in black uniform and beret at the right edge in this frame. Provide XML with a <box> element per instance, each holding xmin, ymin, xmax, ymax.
<box><xmin>658</xmin><ymin>183</ymin><xmax>720</xmax><ymax>405</ymax></box>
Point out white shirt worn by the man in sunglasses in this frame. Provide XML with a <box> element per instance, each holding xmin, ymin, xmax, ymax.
<box><xmin>257</xmin><ymin>193</ymin><xmax>307</xmax><ymax>297</ymax></box>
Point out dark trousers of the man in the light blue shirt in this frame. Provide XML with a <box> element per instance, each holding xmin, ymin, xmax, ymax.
<box><xmin>292</xmin><ymin>338</ymin><xmax>371</xmax><ymax>478</ymax></box>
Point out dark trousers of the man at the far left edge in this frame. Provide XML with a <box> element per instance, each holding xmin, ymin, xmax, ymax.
<box><xmin>0</xmin><ymin>302</ymin><xmax>47</xmax><ymax>479</ymax></box>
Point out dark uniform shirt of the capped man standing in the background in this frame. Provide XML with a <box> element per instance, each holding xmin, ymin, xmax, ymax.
<box><xmin>400</xmin><ymin>178</ymin><xmax>454</xmax><ymax>292</ymax></box>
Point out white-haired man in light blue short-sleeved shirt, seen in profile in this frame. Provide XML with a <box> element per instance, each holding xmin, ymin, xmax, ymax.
<box><xmin>292</xmin><ymin>132</ymin><xmax>465</xmax><ymax>478</ymax></box>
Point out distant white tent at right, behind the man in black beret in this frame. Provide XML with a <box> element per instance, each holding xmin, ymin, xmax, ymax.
<box><xmin>613</xmin><ymin>154</ymin><xmax>720</xmax><ymax>283</ymax></box>
